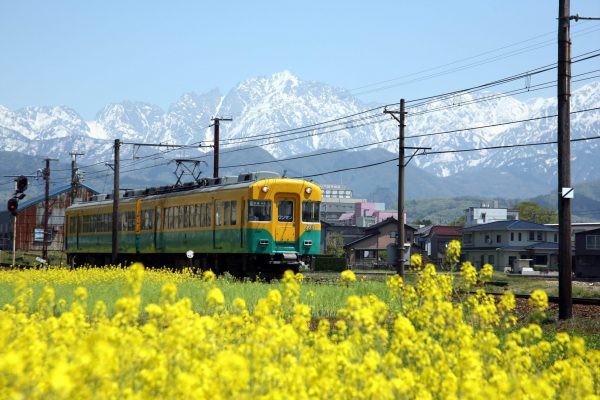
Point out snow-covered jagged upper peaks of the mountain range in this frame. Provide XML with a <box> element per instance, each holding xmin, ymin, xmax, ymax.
<box><xmin>0</xmin><ymin>71</ymin><xmax>600</xmax><ymax>190</ymax></box>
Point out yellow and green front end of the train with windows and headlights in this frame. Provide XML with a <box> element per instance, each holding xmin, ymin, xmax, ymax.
<box><xmin>246</xmin><ymin>178</ymin><xmax>322</xmax><ymax>274</ymax></box>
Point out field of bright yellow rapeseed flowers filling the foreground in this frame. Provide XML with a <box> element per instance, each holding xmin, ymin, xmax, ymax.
<box><xmin>0</xmin><ymin>264</ymin><xmax>600</xmax><ymax>400</ymax></box>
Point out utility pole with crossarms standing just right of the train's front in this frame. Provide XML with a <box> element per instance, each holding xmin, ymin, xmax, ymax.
<box><xmin>383</xmin><ymin>99</ymin><xmax>430</xmax><ymax>278</ymax></box>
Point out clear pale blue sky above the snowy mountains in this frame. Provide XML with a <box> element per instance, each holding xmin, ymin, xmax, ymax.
<box><xmin>0</xmin><ymin>0</ymin><xmax>600</xmax><ymax>119</ymax></box>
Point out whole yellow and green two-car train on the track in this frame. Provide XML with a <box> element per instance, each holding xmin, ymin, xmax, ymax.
<box><xmin>65</xmin><ymin>172</ymin><xmax>322</xmax><ymax>275</ymax></box>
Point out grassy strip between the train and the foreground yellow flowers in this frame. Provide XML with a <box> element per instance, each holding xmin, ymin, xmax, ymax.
<box><xmin>0</xmin><ymin>269</ymin><xmax>389</xmax><ymax>318</ymax></box>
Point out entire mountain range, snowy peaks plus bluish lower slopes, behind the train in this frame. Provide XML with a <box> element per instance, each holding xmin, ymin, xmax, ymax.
<box><xmin>0</xmin><ymin>71</ymin><xmax>600</xmax><ymax>205</ymax></box>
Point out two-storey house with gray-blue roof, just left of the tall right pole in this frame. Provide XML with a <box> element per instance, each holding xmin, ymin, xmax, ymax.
<box><xmin>462</xmin><ymin>220</ymin><xmax>558</xmax><ymax>272</ymax></box>
